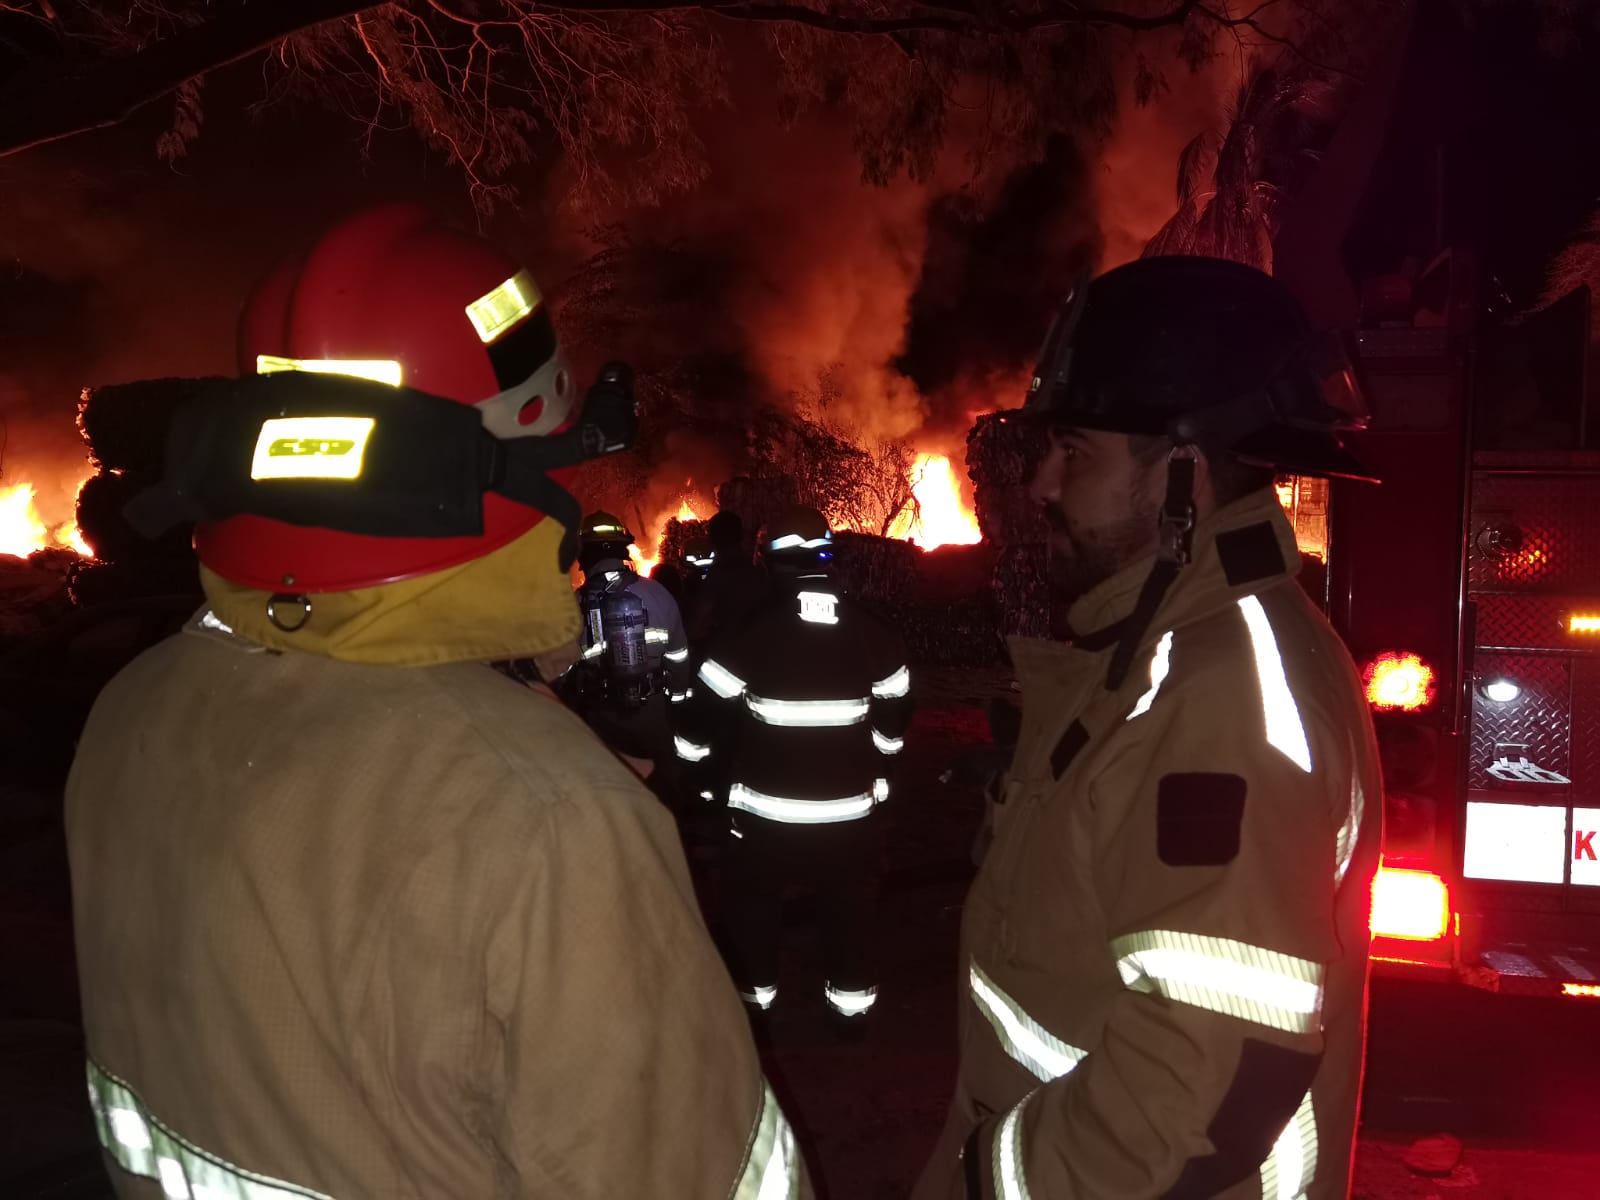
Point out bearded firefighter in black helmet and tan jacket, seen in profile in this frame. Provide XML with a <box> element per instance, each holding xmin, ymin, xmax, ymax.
<box><xmin>915</xmin><ymin>258</ymin><xmax>1382</xmax><ymax>1200</ymax></box>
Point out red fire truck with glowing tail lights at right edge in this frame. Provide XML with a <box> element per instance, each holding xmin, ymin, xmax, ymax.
<box><xmin>1280</xmin><ymin>276</ymin><xmax>1600</xmax><ymax>998</ymax></box>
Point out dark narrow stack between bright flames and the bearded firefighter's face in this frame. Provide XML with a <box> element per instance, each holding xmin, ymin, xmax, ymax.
<box><xmin>966</xmin><ymin>413</ymin><xmax>1050</xmax><ymax>637</ymax></box>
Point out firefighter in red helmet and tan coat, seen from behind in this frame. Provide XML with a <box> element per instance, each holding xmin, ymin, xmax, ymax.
<box><xmin>67</xmin><ymin>205</ymin><xmax>806</xmax><ymax>1200</ymax></box>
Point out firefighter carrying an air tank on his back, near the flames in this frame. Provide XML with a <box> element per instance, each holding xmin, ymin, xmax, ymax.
<box><xmin>565</xmin><ymin>512</ymin><xmax>693</xmax><ymax>771</ymax></box>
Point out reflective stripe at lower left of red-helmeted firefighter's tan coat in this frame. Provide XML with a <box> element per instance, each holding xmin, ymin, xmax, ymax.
<box><xmin>88</xmin><ymin>1059</ymin><xmax>331</xmax><ymax>1200</ymax></box>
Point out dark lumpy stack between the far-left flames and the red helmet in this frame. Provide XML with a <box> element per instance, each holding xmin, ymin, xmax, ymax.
<box><xmin>72</xmin><ymin>379</ymin><xmax>214</xmax><ymax>605</ymax></box>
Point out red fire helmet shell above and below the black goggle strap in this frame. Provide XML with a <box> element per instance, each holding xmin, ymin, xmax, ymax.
<box><xmin>195</xmin><ymin>205</ymin><xmax>576</xmax><ymax>594</ymax></box>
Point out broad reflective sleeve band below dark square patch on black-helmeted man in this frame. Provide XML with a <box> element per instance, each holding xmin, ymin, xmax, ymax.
<box><xmin>1110</xmin><ymin>930</ymin><xmax>1323</xmax><ymax>1034</ymax></box>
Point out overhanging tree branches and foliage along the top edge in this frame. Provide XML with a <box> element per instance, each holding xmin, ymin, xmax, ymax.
<box><xmin>0</xmin><ymin>0</ymin><xmax>1376</xmax><ymax>208</ymax></box>
